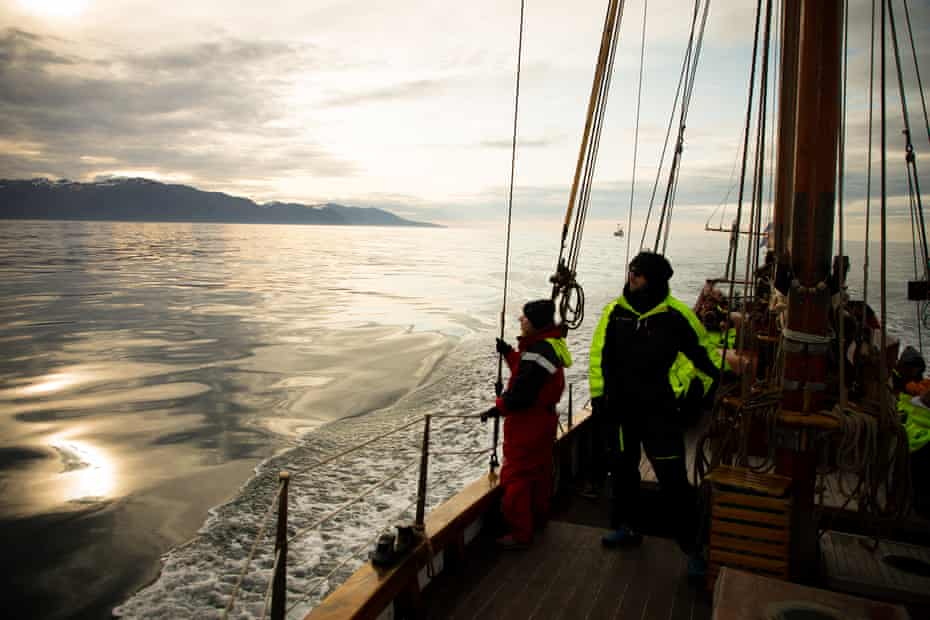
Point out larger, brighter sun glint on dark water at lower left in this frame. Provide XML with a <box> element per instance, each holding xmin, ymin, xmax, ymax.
<box><xmin>50</xmin><ymin>438</ymin><xmax>116</xmax><ymax>502</ymax></box>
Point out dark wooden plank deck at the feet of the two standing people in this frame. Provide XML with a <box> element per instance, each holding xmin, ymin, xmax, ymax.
<box><xmin>425</xmin><ymin>521</ymin><xmax>711</xmax><ymax>620</ymax></box>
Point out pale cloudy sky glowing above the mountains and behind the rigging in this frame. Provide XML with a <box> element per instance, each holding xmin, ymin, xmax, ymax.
<box><xmin>0</xmin><ymin>0</ymin><xmax>930</xmax><ymax>239</ymax></box>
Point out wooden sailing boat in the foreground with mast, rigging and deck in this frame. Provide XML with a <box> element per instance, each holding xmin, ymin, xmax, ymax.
<box><xmin>296</xmin><ymin>0</ymin><xmax>928</xmax><ymax>620</ymax></box>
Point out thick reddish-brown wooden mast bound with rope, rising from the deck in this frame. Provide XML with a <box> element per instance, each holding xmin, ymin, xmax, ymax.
<box><xmin>775</xmin><ymin>0</ymin><xmax>843</xmax><ymax>579</ymax></box>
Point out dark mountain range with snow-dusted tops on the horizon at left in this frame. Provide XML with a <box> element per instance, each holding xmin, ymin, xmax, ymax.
<box><xmin>0</xmin><ymin>178</ymin><xmax>438</xmax><ymax>227</ymax></box>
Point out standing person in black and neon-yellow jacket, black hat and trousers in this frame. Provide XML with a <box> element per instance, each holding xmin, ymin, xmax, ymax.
<box><xmin>589</xmin><ymin>252</ymin><xmax>719</xmax><ymax>576</ymax></box>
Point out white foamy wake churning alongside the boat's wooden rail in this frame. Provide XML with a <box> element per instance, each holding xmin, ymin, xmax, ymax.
<box><xmin>114</xmin><ymin>339</ymin><xmax>528</xmax><ymax>618</ymax></box>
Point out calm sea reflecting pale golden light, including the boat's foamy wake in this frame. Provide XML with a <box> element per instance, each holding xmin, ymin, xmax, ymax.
<box><xmin>0</xmin><ymin>221</ymin><xmax>926</xmax><ymax>618</ymax></box>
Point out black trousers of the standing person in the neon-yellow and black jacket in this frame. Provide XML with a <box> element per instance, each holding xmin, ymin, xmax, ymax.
<box><xmin>607</xmin><ymin>416</ymin><xmax>699</xmax><ymax>553</ymax></box>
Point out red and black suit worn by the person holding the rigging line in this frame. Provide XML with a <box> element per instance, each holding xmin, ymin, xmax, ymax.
<box><xmin>496</xmin><ymin>327</ymin><xmax>571</xmax><ymax>543</ymax></box>
